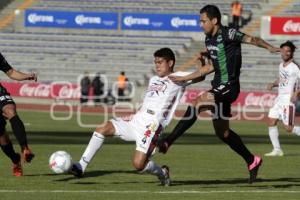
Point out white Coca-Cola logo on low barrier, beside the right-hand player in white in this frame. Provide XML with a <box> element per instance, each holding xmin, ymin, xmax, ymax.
<box><xmin>245</xmin><ymin>93</ymin><xmax>276</xmax><ymax>107</ymax></box>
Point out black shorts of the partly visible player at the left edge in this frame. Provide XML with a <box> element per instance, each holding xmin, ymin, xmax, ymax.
<box><xmin>0</xmin><ymin>85</ymin><xmax>15</xmax><ymax>136</ymax></box>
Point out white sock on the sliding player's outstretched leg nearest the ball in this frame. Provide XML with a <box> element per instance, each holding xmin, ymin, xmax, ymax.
<box><xmin>79</xmin><ymin>132</ymin><xmax>105</xmax><ymax>172</ymax></box>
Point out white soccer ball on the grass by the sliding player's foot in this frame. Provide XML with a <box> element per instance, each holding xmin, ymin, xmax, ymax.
<box><xmin>49</xmin><ymin>151</ymin><xmax>72</xmax><ymax>174</ymax></box>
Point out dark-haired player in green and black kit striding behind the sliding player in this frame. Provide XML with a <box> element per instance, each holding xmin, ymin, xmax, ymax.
<box><xmin>158</xmin><ymin>5</ymin><xmax>280</xmax><ymax>183</ymax></box>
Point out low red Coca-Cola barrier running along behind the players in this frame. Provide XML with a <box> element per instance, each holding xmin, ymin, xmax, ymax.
<box><xmin>1</xmin><ymin>82</ymin><xmax>277</xmax><ymax>108</ymax></box>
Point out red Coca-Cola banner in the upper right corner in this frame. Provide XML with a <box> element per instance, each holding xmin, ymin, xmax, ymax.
<box><xmin>270</xmin><ymin>17</ymin><xmax>300</xmax><ymax>35</ymax></box>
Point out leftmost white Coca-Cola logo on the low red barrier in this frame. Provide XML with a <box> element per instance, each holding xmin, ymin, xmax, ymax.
<box><xmin>20</xmin><ymin>84</ymin><xmax>50</xmax><ymax>97</ymax></box>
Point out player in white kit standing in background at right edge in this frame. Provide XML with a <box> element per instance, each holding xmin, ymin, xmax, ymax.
<box><xmin>265</xmin><ymin>41</ymin><xmax>300</xmax><ymax>156</ymax></box>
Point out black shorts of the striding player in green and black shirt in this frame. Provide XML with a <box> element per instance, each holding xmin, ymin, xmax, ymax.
<box><xmin>208</xmin><ymin>83</ymin><xmax>240</xmax><ymax>120</ymax></box>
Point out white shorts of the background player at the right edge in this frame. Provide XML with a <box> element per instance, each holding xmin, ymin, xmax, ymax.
<box><xmin>268</xmin><ymin>103</ymin><xmax>295</xmax><ymax>126</ymax></box>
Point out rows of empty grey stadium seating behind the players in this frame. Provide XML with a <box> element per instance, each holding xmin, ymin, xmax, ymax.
<box><xmin>0</xmin><ymin>0</ymin><xmax>300</xmax><ymax>90</ymax></box>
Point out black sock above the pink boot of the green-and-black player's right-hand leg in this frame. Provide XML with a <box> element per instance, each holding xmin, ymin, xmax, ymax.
<box><xmin>221</xmin><ymin>130</ymin><xmax>254</xmax><ymax>165</ymax></box>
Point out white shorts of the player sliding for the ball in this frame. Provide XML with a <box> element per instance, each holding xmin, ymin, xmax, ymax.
<box><xmin>110</xmin><ymin>113</ymin><xmax>162</xmax><ymax>156</ymax></box>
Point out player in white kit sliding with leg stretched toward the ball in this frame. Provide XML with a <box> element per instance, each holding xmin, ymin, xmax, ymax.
<box><xmin>70</xmin><ymin>48</ymin><xmax>198</xmax><ymax>186</ymax></box>
